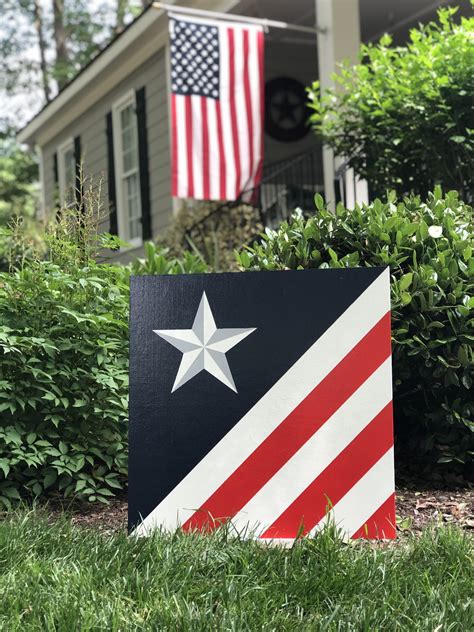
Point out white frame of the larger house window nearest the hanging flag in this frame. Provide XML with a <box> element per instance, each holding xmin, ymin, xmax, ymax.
<box><xmin>112</xmin><ymin>90</ymin><xmax>143</xmax><ymax>250</ymax></box>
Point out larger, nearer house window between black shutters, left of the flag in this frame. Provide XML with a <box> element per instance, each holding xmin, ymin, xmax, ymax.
<box><xmin>113</xmin><ymin>92</ymin><xmax>142</xmax><ymax>246</ymax></box>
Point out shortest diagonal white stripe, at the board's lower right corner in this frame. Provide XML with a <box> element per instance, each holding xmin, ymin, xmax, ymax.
<box><xmin>310</xmin><ymin>448</ymin><xmax>395</xmax><ymax>539</ymax></box>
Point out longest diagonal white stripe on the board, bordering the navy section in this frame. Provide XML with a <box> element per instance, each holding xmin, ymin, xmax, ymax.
<box><xmin>135</xmin><ymin>269</ymin><xmax>390</xmax><ymax>534</ymax></box>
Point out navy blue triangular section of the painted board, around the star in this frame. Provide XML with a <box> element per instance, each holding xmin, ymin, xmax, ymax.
<box><xmin>129</xmin><ymin>268</ymin><xmax>382</xmax><ymax>525</ymax></box>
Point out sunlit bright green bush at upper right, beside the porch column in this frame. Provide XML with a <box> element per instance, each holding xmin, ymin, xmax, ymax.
<box><xmin>309</xmin><ymin>8</ymin><xmax>474</xmax><ymax>199</ymax></box>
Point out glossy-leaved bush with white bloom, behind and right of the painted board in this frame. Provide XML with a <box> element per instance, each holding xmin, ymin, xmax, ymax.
<box><xmin>238</xmin><ymin>189</ymin><xmax>474</xmax><ymax>472</ymax></box>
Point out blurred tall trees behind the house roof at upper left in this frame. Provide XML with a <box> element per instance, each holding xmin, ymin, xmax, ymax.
<box><xmin>0</xmin><ymin>0</ymin><xmax>142</xmax><ymax>227</ymax></box>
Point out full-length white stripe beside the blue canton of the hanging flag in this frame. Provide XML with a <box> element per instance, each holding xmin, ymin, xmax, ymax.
<box><xmin>219</xmin><ymin>25</ymin><xmax>236</xmax><ymax>200</ymax></box>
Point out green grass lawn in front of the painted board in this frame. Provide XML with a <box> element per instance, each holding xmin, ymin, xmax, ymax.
<box><xmin>0</xmin><ymin>511</ymin><xmax>474</xmax><ymax>632</ymax></box>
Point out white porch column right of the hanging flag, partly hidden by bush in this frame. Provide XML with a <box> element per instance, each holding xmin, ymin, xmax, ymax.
<box><xmin>315</xmin><ymin>0</ymin><xmax>360</xmax><ymax>207</ymax></box>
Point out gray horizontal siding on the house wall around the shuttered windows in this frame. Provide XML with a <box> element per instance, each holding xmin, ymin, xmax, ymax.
<box><xmin>42</xmin><ymin>48</ymin><xmax>172</xmax><ymax>256</ymax></box>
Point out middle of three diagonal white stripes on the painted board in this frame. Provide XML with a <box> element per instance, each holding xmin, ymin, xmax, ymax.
<box><xmin>232</xmin><ymin>358</ymin><xmax>392</xmax><ymax>534</ymax></box>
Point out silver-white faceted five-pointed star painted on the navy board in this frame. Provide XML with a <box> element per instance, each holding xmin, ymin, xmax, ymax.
<box><xmin>153</xmin><ymin>292</ymin><xmax>256</xmax><ymax>393</ymax></box>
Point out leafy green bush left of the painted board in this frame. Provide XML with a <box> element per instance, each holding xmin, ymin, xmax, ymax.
<box><xmin>0</xmin><ymin>207</ymin><xmax>205</xmax><ymax>507</ymax></box>
